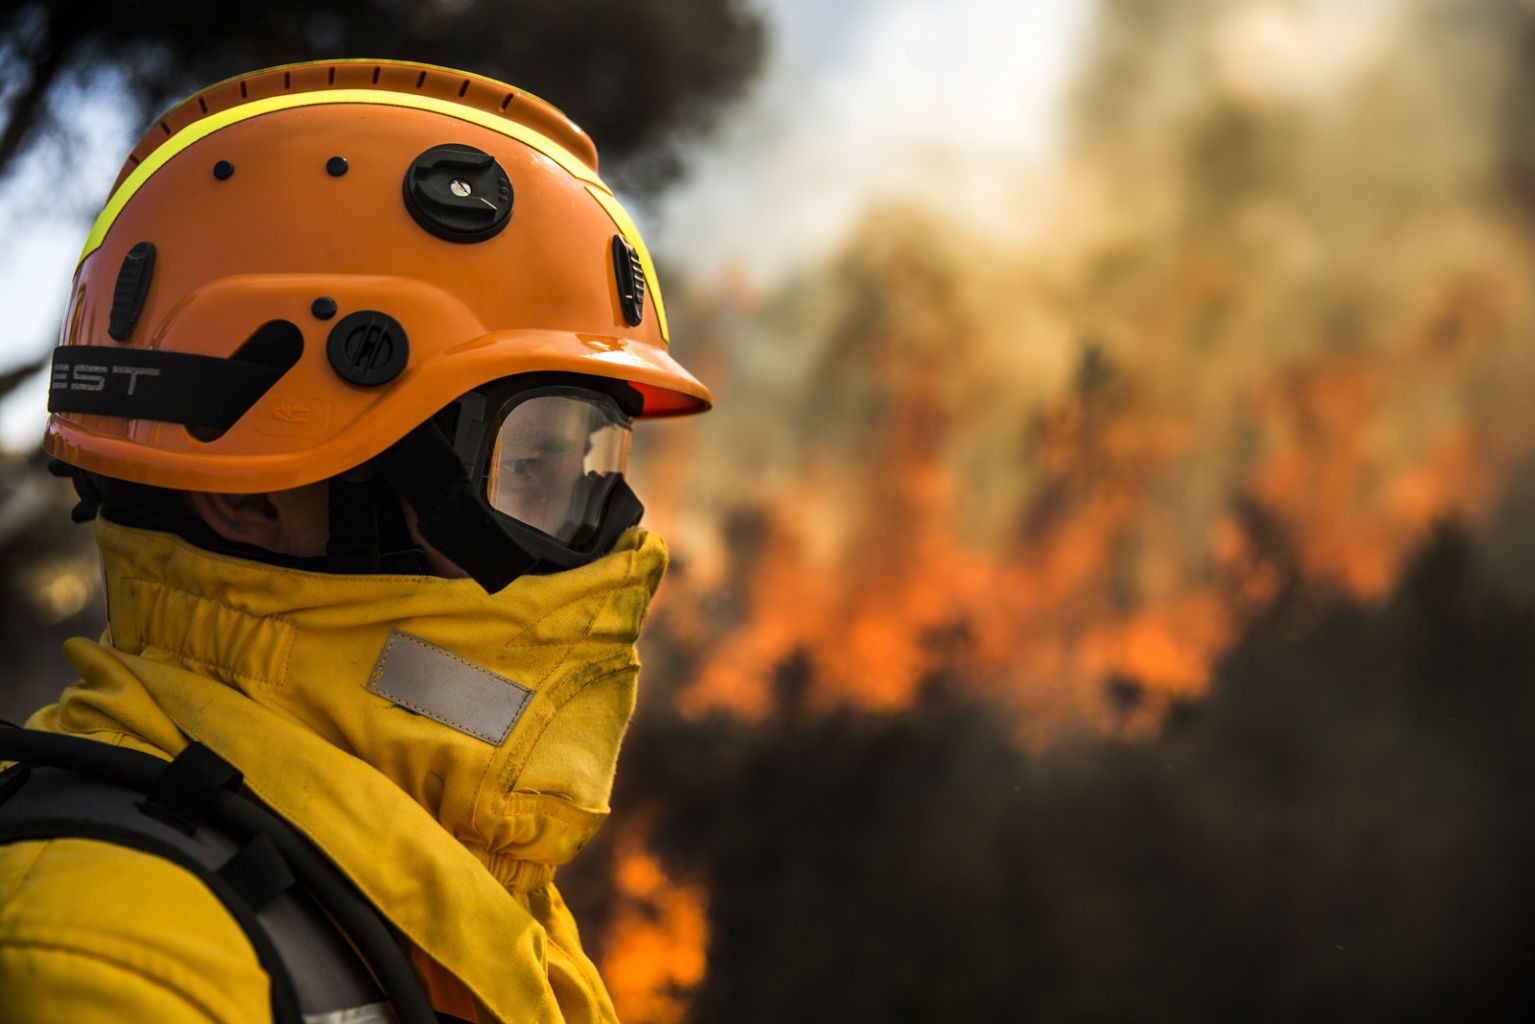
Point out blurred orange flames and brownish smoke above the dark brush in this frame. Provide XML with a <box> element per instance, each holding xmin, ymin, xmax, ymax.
<box><xmin>626</xmin><ymin>2</ymin><xmax>1535</xmax><ymax>738</ymax></box>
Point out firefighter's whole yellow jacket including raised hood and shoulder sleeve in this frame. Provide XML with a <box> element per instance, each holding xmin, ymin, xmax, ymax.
<box><xmin>0</xmin><ymin>522</ymin><xmax>666</xmax><ymax>1024</ymax></box>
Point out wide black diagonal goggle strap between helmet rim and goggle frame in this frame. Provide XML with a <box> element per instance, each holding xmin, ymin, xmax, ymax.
<box><xmin>378</xmin><ymin>419</ymin><xmax>539</xmax><ymax>594</ymax></box>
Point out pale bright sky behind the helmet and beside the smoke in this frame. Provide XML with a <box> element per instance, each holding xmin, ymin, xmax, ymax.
<box><xmin>0</xmin><ymin>0</ymin><xmax>1091</xmax><ymax>450</ymax></box>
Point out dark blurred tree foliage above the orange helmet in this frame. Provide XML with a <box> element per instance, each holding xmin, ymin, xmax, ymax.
<box><xmin>0</xmin><ymin>0</ymin><xmax>763</xmax><ymax>193</ymax></box>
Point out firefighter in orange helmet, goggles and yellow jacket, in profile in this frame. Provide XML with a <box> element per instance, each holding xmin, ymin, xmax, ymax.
<box><xmin>0</xmin><ymin>61</ymin><xmax>711</xmax><ymax>1024</ymax></box>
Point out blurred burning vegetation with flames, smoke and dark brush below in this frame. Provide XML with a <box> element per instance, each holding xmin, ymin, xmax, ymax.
<box><xmin>571</xmin><ymin>0</ymin><xmax>1535</xmax><ymax>1022</ymax></box>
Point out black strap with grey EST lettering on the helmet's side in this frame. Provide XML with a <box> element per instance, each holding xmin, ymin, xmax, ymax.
<box><xmin>48</xmin><ymin>345</ymin><xmax>287</xmax><ymax>430</ymax></box>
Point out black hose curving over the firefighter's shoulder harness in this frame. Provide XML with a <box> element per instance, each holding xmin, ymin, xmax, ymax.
<box><xmin>0</xmin><ymin>725</ymin><xmax>437</xmax><ymax>1024</ymax></box>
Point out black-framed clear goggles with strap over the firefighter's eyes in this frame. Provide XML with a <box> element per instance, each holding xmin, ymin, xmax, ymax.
<box><xmin>327</xmin><ymin>373</ymin><xmax>645</xmax><ymax>593</ymax></box>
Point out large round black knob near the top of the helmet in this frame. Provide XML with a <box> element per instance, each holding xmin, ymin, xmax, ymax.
<box><xmin>405</xmin><ymin>144</ymin><xmax>511</xmax><ymax>243</ymax></box>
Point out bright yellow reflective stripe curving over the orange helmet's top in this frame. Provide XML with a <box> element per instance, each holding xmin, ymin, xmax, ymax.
<box><xmin>75</xmin><ymin>89</ymin><xmax>607</xmax><ymax>264</ymax></box>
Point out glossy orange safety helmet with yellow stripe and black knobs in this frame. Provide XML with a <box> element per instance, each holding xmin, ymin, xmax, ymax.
<box><xmin>45</xmin><ymin>60</ymin><xmax>711</xmax><ymax>592</ymax></box>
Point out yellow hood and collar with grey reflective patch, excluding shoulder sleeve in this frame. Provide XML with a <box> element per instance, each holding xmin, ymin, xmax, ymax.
<box><xmin>31</xmin><ymin>520</ymin><xmax>666</xmax><ymax>1021</ymax></box>
